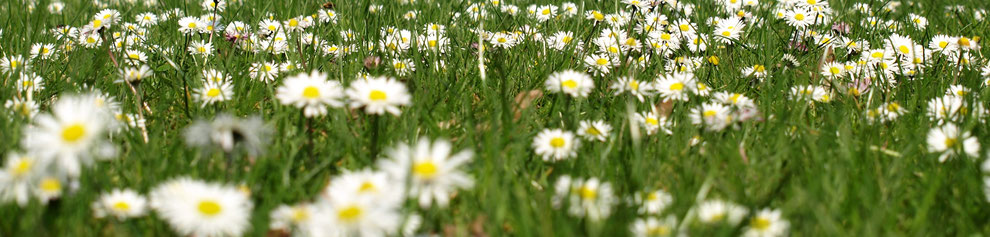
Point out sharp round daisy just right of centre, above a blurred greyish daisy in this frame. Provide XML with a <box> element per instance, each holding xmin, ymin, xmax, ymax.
<box><xmin>533</xmin><ymin>129</ymin><xmax>581</xmax><ymax>161</ymax></box>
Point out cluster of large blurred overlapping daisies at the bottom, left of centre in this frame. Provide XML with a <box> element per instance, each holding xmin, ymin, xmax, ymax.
<box><xmin>270</xmin><ymin>139</ymin><xmax>474</xmax><ymax>236</ymax></box>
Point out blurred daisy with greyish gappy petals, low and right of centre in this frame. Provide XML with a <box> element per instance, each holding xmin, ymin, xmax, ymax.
<box><xmin>553</xmin><ymin>175</ymin><xmax>618</xmax><ymax>221</ymax></box>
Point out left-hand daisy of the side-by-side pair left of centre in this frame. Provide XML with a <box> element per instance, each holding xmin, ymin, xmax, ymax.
<box><xmin>276</xmin><ymin>71</ymin><xmax>344</xmax><ymax>117</ymax></box>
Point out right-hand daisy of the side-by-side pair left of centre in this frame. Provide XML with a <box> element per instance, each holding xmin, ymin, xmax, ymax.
<box><xmin>346</xmin><ymin>77</ymin><xmax>412</xmax><ymax>116</ymax></box>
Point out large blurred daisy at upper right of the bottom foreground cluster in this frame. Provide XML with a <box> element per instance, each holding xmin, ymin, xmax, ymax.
<box><xmin>379</xmin><ymin>139</ymin><xmax>474</xmax><ymax>208</ymax></box>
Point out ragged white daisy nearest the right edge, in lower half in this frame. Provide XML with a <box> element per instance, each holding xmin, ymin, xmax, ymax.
<box><xmin>927</xmin><ymin>123</ymin><xmax>980</xmax><ymax>162</ymax></box>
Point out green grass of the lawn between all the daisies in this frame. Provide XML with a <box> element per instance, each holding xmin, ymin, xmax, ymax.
<box><xmin>0</xmin><ymin>0</ymin><xmax>990</xmax><ymax>236</ymax></box>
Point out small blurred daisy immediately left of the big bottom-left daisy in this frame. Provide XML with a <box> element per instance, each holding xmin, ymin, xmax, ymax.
<box><xmin>93</xmin><ymin>189</ymin><xmax>148</xmax><ymax>220</ymax></box>
